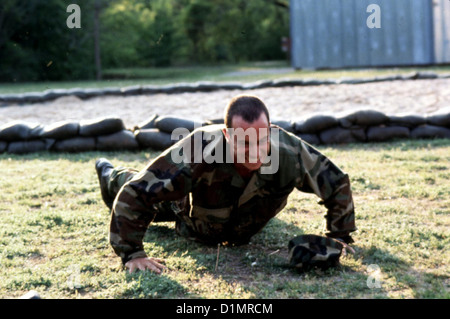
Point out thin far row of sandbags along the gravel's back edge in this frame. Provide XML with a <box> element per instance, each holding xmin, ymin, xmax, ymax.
<box><xmin>0</xmin><ymin>72</ymin><xmax>450</xmax><ymax>106</ymax></box>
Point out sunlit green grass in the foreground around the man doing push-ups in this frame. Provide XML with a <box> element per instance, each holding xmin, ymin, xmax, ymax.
<box><xmin>0</xmin><ymin>140</ymin><xmax>450</xmax><ymax>299</ymax></box>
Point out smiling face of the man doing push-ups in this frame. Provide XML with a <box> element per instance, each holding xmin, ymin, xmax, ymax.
<box><xmin>225</xmin><ymin>113</ymin><xmax>270</xmax><ymax>171</ymax></box>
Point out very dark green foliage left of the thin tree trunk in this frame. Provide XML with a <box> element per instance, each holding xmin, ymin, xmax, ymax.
<box><xmin>0</xmin><ymin>0</ymin><xmax>93</xmax><ymax>82</ymax></box>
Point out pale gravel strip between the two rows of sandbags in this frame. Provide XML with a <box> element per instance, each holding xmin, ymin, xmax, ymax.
<box><xmin>0</xmin><ymin>79</ymin><xmax>450</xmax><ymax>128</ymax></box>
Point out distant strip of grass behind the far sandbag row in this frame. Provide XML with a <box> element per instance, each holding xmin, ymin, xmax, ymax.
<box><xmin>0</xmin><ymin>61</ymin><xmax>450</xmax><ymax>94</ymax></box>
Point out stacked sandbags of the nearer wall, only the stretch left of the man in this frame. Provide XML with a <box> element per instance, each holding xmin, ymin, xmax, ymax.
<box><xmin>0</xmin><ymin>116</ymin><xmax>207</xmax><ymax>154</ymax></box>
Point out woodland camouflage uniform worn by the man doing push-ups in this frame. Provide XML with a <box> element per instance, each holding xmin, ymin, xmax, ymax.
<box><xmin>108</xmin><ymin>125</ymin><xmax>356</xmax><ymax>263</ymax></box>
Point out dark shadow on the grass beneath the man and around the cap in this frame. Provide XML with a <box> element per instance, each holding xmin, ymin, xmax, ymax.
<box><xmin>110</xmin><ymin>218</ymin><xmax>420</xmax><ymax>299</ymax></box>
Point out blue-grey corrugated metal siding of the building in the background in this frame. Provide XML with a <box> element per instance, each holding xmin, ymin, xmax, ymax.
<box><xmin>290</xmin><ymin>0</ymin><xmax>436</xmax><ymax>68</ymax></box>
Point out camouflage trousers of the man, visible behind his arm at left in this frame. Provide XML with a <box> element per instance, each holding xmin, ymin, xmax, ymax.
<box><xmin>107</xmin><ymin>167</ymin><xmax>191</xmax><ymax>228</ymax></box>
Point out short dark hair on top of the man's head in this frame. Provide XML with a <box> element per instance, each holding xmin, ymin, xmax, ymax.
<box><xmin>225</xmin><ymin>95</ymin><xmax>270</xmax><ymax>128</ymax></box>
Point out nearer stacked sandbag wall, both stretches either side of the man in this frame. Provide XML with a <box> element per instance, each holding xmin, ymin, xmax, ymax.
<box><xmin>0</xmin><ymin>110</ymin><xmax>450</xmax><ymax>154</ymax></box>
